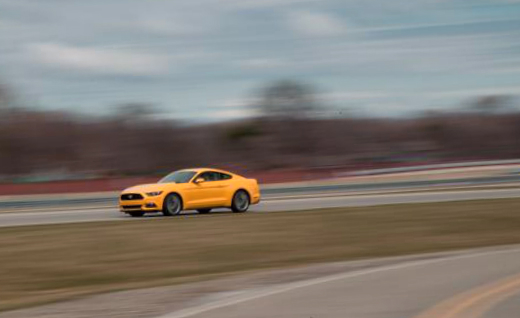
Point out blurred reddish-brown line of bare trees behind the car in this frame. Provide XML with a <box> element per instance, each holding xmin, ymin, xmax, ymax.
<box><xmin>0</xmin><ymin>82</ymin><xmax>520</xmax><ymax>180</ymax></box>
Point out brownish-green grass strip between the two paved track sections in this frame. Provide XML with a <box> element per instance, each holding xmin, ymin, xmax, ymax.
<box><xmin>0</xmin><ymin>199</ymin><xmax>520</xmax><ymax>310</ymax></box>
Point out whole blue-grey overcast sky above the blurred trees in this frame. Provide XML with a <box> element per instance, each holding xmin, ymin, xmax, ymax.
<box><xmin>0</xmin><ymin>0</ymin><xmax>520</xmax><ymax>121</ymax></box>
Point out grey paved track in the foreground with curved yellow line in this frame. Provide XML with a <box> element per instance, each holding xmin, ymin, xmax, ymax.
<box><xmin>158</xmin><ymin>248</ymin><xmax>520</xmax><ymax>318</ymax></box>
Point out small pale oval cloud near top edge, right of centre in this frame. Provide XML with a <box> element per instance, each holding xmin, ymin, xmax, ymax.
<box><xmin>288</xmin><ymin>11</ymin><xmax>347</xmax><ymax>36</ymax></box>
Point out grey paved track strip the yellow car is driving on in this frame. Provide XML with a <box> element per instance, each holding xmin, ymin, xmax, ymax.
<box><xmin>0</xmin><ymin>189</ymin><xmax>520</xmax><ymax>227</ymax></box>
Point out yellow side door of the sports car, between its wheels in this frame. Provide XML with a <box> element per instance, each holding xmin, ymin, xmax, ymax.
<box><xmin>188</xmin><ymin>171</ymin><xmax>225</xmax><ymax>209</ymax></box>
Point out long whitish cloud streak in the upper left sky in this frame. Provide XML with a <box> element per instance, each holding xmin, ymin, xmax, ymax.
<box><xmin>27</xmin><ymin>43</ymin><xmax>168</xmax><ymax>76</ymax></box>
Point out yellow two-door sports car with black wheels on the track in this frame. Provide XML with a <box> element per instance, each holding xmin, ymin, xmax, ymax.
<box><xmin>119</xmin><ymin>168</ymin><xmax>260</xmax><ymax>217</ymax></box>
